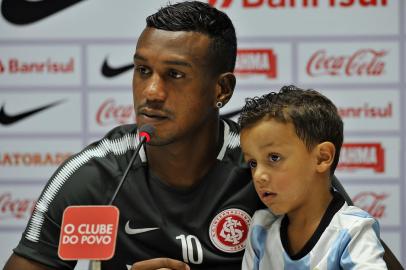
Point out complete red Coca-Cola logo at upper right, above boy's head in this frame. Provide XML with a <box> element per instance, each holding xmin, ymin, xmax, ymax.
<box><xmin>306</xmin><ymin>49</ymin><xmax>388</xmax><ymax>77</ymax></box>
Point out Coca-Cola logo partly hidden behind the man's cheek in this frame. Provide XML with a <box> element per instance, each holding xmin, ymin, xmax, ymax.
<box><xmin>96</xmin><ymin>98</ymin><xmax>135</xmax><ymax>126</ymax></box>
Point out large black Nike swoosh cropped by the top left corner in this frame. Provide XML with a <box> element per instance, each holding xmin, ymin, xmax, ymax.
<box><xmin>1</xmin><ymin>0</ymin><xmax>83</xmax><ymax>25</ymax></box>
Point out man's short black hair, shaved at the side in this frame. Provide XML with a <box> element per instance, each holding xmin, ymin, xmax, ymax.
<box><xmin>146</xmin><ymin>1</ymin><xmax>237</xmax><ymax>73</ymax></box>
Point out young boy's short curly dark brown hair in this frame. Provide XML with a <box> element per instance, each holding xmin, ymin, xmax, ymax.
<box><xmin>238</xmin><ymin>85</ymin><xmax>344</xmax><ymax>175</ymax></box>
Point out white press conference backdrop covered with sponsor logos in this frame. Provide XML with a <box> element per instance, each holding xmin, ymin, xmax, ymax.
<box><xmin>0</xmin><ymin>0</ymin><xmax>406</xmax><ymax>268</ymax></box>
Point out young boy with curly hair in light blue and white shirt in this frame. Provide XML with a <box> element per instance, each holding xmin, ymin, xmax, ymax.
<box><xmin>239</xmin><ymin>86</ymin><xmax>387</xmax><ymax>270</ymax></box>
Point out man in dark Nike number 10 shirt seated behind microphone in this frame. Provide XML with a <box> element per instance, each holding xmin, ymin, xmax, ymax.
<box><xmin>5</xmin><ymin>2</ymin><xmax>261</xmax><ymax>270</ymax></box>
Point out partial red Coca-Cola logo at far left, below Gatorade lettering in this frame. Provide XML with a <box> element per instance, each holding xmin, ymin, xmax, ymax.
<box><xmin>0</xmin><ymin>192</ymin><xmax>36</xmax><ymax>221</ymax></box>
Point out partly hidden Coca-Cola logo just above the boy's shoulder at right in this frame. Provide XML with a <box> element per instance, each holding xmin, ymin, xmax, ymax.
<box><xmin>352</xmin><ymin>191</ymin><xmax>389</xmax><ymax>219</ymax></box>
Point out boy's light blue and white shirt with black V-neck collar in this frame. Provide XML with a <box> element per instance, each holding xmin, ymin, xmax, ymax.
<box><xmin>242</xmin><ymin>195</ymin><xmax>387</xmax><ymax>270</ymax></box>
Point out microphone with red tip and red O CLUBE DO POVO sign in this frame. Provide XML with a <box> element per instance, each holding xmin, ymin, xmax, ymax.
<box><xmin>58</xmin><ymin>125</ymin><xmax>155</xmax><ymax>261</ymax></box>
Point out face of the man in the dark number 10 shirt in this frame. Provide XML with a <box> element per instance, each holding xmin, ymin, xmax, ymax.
<box><xmin>133</xmin><ymin>28</ymin><xmax>217</xmax><ymax>145</ymax></box>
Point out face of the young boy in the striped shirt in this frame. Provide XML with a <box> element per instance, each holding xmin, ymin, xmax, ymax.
<box><xmin>241</xmin><ymin>119</ymin><xmax>322</xmax><ymax>214</ymax></box>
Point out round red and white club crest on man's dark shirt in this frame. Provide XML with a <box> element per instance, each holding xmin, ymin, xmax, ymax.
<box><xmin>209</xmin><ymin>208</ymin><xmax>251</xmax><ymax>253</ymax></box>
